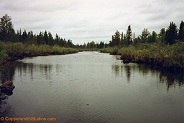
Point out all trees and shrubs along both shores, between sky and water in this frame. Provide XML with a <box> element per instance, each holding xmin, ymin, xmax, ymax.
<box><xmin>0</xmin><ymin>14</ymin><xmax>184</xmax><ymax>70</ymax></box>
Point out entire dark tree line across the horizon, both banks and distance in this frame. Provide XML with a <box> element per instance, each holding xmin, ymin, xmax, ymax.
<box><xmin>0</xmin><ymin>14</ymin><xmax>184</xmax><ymax>49</ymax></box>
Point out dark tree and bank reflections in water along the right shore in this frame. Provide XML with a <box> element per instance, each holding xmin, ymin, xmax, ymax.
<box><xmin>112</xmin><ymin>64</ymin><xmax>184</xmax><ymax>89</ymax></box>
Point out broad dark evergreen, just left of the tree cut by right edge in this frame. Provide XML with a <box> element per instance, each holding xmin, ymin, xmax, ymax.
<box><xmin>165</xmin><ymin>22</ymin><xmax>177</xmax><ymax>44</ymax></box>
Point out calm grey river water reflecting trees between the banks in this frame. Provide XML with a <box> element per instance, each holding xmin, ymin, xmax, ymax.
<box><xmin>0</xmin><ymin>52</ymin><xmax>184</xmax><ymax>123</ymax></box>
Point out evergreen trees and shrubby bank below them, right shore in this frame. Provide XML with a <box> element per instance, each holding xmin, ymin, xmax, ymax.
<box><xmin>101</xmin><ymin>21</ymin><xmax>184</xmax><ymax>71</ymax></box>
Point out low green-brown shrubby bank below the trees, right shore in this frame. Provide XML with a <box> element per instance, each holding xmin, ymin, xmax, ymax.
<box><xmin>101</xmin><ymin>42</ymin><xmax>184</xmax><ymax>70</ymax></box>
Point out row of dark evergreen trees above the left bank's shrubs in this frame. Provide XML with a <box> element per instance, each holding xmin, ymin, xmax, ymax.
<box><xmin>0</xmin><ymin>14</ymin><xmax>74</xmax><ymax>47</ymax></box>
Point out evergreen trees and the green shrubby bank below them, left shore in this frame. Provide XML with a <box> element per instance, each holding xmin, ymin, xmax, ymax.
<box><xmin>0</xmin><ymin>14</ymin><xmax>78</xmax><ymax>64</ymax></box>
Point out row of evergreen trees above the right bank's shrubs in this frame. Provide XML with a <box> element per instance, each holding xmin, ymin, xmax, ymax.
<box><xmin>108</xmin><ymin>21</ymin><xmax>184</xmax><ymax>47</ymax></box>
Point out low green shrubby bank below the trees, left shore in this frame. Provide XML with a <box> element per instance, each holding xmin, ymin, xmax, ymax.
<box><xmin>0</xmin><ymin>42</ymin><xmax>78</xmax><ymax>64</ymax></box>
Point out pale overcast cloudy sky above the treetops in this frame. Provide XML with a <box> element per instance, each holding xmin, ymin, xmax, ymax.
<box><xmin>0</xmin><ymin>0</ymin><xmax>184</xmax><ymax>44</ymax></box>
